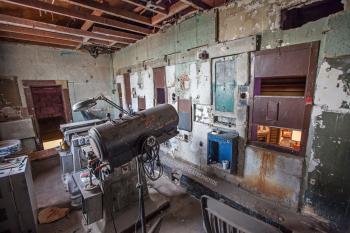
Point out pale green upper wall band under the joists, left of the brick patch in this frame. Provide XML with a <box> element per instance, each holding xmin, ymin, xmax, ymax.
<box><xmin>114</xmin><ymin>11</ymin><xmax>216</xmax><ymax>70</ymax></box>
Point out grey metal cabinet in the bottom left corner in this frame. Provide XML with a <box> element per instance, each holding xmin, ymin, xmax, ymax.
<box><xmin>0</xmin><ymin>156</ymin><xmax>37</xmax><ymax>233</ymax></box>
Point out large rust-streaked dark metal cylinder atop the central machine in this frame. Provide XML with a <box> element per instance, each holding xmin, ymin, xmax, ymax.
<box><xmin>89</xmin><ymin>104</ymin><xmax>179</xmax><ymax>167</ymax></box>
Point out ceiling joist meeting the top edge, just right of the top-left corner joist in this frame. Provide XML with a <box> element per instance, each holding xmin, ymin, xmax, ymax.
<box><xmin>64</xmin><ymin>0</ymin><xmax>152</xmax><ymax>26</ymax></box>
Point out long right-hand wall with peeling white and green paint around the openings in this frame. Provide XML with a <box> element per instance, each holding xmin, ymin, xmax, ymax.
<box><xmin>115</xmin><ymin>0</ymin><xmax>350</xmax><ymax>227</ymax></box>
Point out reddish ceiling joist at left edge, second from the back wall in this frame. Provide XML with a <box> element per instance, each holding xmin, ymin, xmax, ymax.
<box><xmin>0</xmin><ymin>14</ymin><xmax>134</xmax><ymax>44</ymax></box>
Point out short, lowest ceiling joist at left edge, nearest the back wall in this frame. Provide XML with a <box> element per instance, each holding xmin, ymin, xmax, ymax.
<box><xmin>0</xmin><ymin>24</ymin><xmax>83</xmax><ymax>43</ymax></box>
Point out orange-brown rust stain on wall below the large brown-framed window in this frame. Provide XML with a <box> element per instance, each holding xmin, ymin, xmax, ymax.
<box><xmin>244</xmin><ymin>151</ymin><xmax>292</xmax><ymax>200</ymax></box>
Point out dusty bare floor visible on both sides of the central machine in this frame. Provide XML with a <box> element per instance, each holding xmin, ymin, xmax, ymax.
<box><xmin>32</xmin><ymin>157</ymin><xmax>204</xmax><ymax>233</ymax></box>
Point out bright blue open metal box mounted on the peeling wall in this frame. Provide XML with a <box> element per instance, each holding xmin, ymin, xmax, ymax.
<box><xmin>207</xmin><ymin>132</ymin><xmax>239</xmax><ymax>174</ymax></box>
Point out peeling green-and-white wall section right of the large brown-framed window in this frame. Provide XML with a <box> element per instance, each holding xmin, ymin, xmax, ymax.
<box><xmin>304</xmin><ymin>12</ymin><xmax>350</xmax><ymax>230</ymax></box>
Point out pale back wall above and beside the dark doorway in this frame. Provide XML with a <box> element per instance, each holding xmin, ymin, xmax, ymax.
<box><xmin>0</xmin><ymin>42</ymin><xmax>113</xmax><ymax>121</ymax></box>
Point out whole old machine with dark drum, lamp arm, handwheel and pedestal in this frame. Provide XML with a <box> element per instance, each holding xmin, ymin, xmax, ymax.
<box><xmin>73</xmin><ymin>98</ymin><xmax>179</xmax><ymax>233</ymax></box>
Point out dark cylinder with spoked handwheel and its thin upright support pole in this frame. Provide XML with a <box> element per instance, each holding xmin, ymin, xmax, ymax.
<box><xmin>89</xmin><ymin>104</ymin><xmax>179</xmax><ymax>233</ymax></box>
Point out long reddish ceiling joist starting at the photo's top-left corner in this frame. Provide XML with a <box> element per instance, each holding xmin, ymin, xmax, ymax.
<box><xmin>0</xmin><ymin>0</ymin><xmax>152</xmax><ymax>35</ymax></box>
